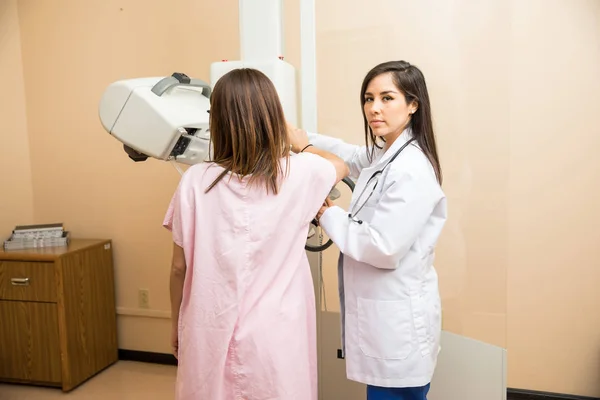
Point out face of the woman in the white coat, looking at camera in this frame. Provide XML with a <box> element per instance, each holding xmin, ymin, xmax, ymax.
<box><xmin>364</xmin><ymin>72</ymin><xmax>417</xmax><ymax>146</ymax></box>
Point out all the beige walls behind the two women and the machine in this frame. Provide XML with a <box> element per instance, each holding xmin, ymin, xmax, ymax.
<box><xmin>0</xmin><ymin>0</ymin><xmax>600</xmax><ymax>397</ymax></box>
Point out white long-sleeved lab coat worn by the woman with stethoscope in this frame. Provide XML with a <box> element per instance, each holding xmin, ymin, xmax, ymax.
<box><xmin>309</xmin><ymin>130</ymin><xmax>446</xmax><ymax>387</ymax></box>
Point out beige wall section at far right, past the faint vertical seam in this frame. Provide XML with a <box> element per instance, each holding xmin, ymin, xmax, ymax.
<box><xmin>507</xmin><ymin>0</ymin><xmax>600</xmax><ymax>397</ymax></box>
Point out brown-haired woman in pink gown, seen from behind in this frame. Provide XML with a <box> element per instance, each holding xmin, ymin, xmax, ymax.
<box><xmin>164</xmin><ymin>69</ymin><xmax>348</xmax><ymax>400</ymax></box>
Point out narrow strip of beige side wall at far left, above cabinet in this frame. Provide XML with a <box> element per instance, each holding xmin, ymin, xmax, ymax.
<box><xmin>0</xmin><ymin>0</ymin><xmax>33</xmax><ymax>236</ymax></box>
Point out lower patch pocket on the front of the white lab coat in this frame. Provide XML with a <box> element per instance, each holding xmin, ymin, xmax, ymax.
<box><xmin>358</xmin><ymin>297</ymin><xmax>413</xmax><ymax>360</ymax></box>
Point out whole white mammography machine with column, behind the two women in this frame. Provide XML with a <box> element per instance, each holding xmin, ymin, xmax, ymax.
<box><xmin>99</xmin><ymin>0</ymin><xmax>506</xmax><ymax>400</ymax></box>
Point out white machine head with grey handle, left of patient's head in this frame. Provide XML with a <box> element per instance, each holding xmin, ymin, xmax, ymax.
<box><xmin>99</xmin><ymin>73</ymin><xmax>211</xmax><ymax>164</ymax></box>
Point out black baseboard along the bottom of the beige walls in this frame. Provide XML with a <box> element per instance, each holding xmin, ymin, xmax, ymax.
<box><xmin>119</xmin><ymin>349</ymin><xmax>600</xmax><ymax>400</ymax></box>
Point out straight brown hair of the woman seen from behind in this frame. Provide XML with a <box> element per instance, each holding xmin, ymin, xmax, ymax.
<box><xmin>206</xmin><ymin>68</ymin><xmax>290</xmax><ymax>193</ymax></box>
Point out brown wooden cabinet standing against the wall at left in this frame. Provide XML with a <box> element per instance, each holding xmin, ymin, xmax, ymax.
<box><xmin>0</xmin><ymin>239</ymin><xmax>118</xmax><ymax>391</ymax></box>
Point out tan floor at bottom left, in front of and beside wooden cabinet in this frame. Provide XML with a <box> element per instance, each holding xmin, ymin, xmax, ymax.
<box><xmin>0</xmin><ymin>361</ymin><xmax>176</xmax><ymax>400</ymax></box>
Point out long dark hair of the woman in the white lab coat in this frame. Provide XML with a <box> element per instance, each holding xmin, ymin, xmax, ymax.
<box><xmin>360</xmin><ymin>61</ymin><xmax>442</xmax><ymax>185</ymax></box>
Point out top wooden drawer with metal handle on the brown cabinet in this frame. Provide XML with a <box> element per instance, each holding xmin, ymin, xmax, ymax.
<box><xmin>0</xmin><ymin>261</ymin><xmax>56</xmax><ymax>302</ymax></box>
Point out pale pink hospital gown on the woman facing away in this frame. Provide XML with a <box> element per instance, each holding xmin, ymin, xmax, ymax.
<box><xmin>164</xmin><ymin>153</ymin><xmax>336</xmax><ymax>400</ymax></box>
